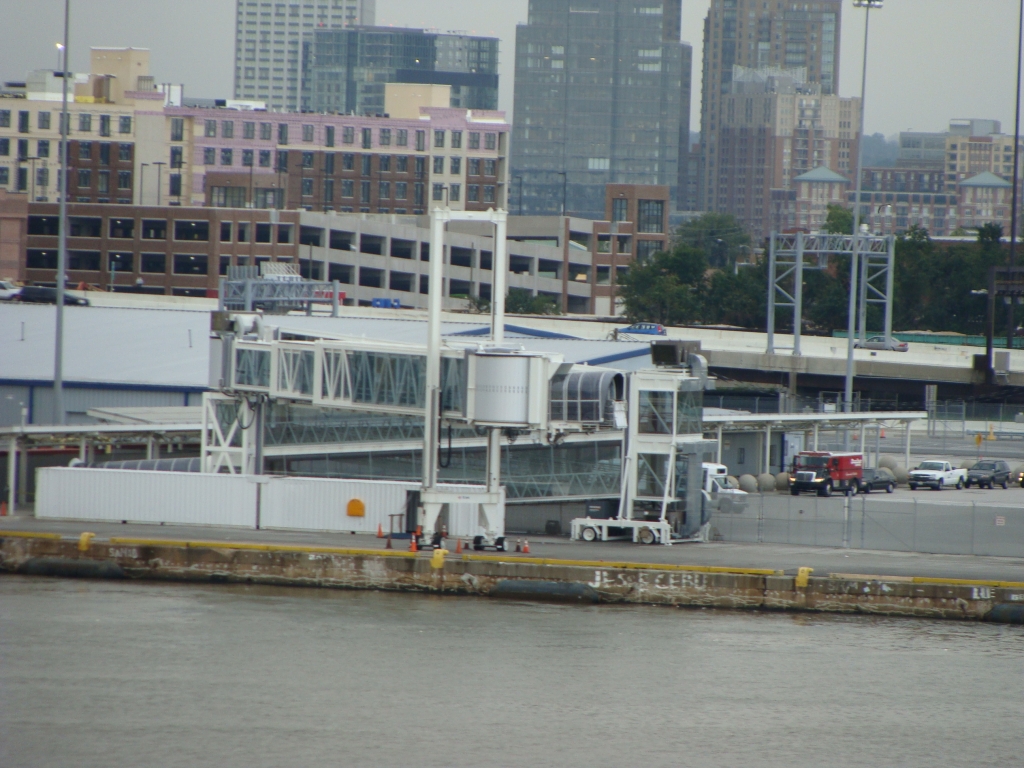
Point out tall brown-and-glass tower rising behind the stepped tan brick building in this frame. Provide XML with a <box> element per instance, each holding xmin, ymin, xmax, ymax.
<box><xmin>698</xmin><ymin>0</ymin><xmax>842</xmax><ymax>213</ymax></box>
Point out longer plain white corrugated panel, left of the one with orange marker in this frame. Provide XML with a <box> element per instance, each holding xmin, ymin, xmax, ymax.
<box><xmin>36</xmin><ymin>467</ymin><xmax>256</xmax><ymax>528</ymax></box>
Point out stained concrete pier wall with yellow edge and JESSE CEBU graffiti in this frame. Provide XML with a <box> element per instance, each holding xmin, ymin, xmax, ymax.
<box><xmin>0</xmin><ymin>531</ymin><xmax>1024</xmax><ymax>620</ymax></box>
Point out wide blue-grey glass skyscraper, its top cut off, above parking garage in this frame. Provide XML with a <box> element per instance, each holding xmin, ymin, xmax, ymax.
<box><xmin>511</xmin><ymin>0</ymin><xmax>692</xmax><ymax>218</ymax></box>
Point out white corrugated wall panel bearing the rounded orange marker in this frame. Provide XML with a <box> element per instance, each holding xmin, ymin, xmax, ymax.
<box><xmin>260</xmin><ymin>476</ymin><xmax>420</xmax><ymax>534</ymax></box>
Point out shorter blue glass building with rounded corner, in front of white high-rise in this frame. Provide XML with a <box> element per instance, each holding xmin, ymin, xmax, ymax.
<box><xmin>302</xmin><ymin>27</ymin><xmax>498</xmax><ymax>115</ymax></box>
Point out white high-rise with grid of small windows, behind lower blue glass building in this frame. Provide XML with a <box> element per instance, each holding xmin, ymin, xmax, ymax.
<box><xmin>234</xmin><ymin>0</ymin><xmax>376</xmax><ymax>112</ymax></box>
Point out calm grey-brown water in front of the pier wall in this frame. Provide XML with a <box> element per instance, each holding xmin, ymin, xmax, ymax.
<box><xmin>0</xmin><ymin>577</ymin><xmax>1024</xmax><ymax>768</ymax></box>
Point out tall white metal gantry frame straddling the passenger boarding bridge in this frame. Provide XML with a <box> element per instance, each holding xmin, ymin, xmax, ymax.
<box><xmin>420</xmin><ymin>208</ymin><xmax>508</xmax><ymax>538</ymax></box>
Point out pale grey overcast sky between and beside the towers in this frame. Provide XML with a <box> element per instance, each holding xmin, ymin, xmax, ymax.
<box><xmin>0</xmin><ymin>0</ymin><xmax>1018</xmax><ymax>135</ymax></box>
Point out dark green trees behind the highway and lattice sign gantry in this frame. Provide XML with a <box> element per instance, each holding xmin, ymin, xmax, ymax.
<box><xmin>618</xmin><ymin>206</ymin><xmax>1007</xmax><ymax>335</ymax></box>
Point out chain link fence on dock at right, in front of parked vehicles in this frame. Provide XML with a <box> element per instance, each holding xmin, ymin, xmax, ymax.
<box><xmin>711</xmin><ymin>494</ymin><xmax>1024</xmax><ymax>557</ymax></box>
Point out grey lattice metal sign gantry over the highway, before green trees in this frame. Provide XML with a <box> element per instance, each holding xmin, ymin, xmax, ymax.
<box><xmin>767</xmin><ymin>232</ymin><xmax>896</xmax><ymax>356</ymax></box>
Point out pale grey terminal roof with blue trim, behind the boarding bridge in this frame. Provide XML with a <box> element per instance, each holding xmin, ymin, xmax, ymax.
<box><xmin>0</xmin><ymin>302</ymin><xmax>650</xmax><ymax>391</ymax></box>
